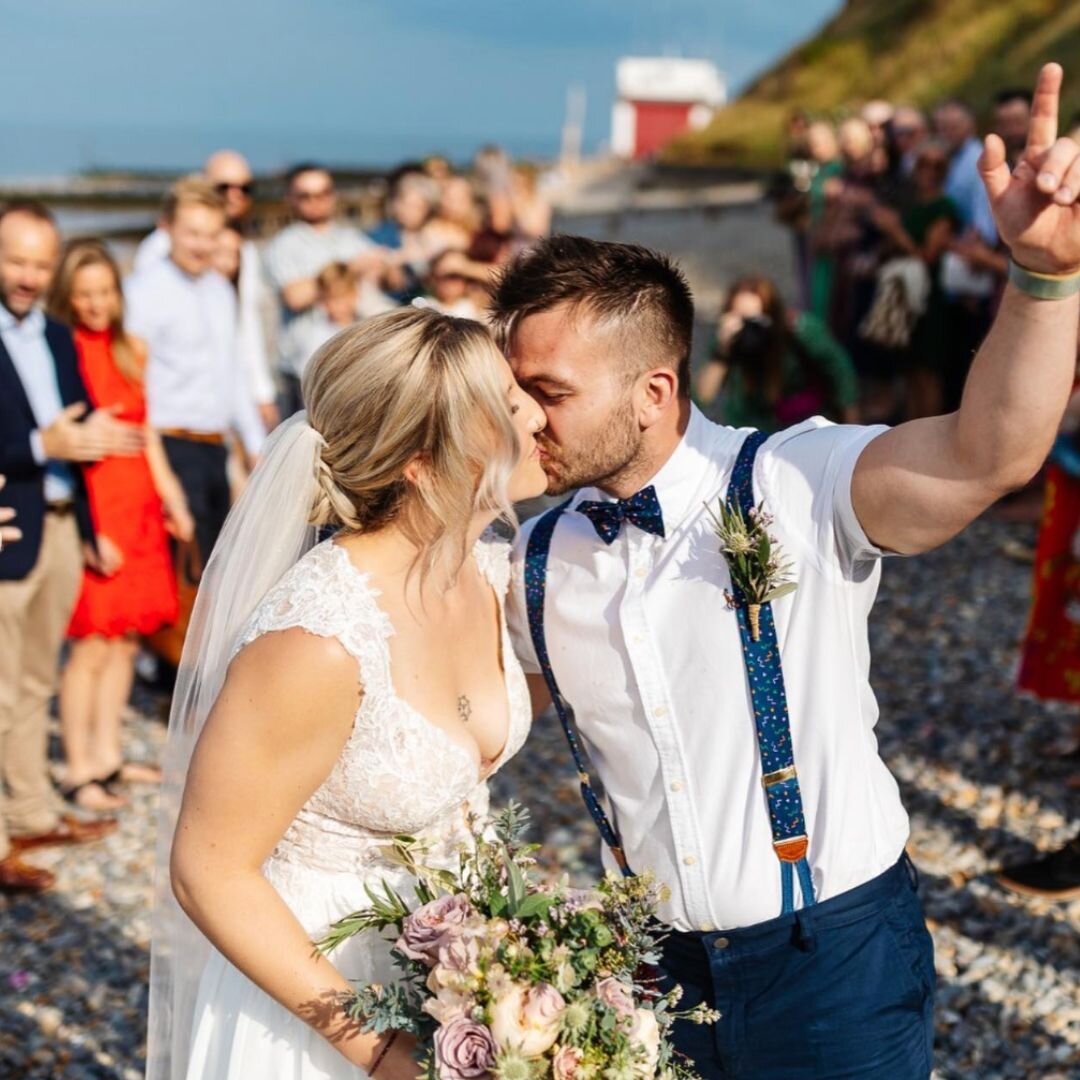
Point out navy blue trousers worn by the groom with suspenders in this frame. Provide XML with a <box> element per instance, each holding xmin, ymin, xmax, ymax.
<box><xmin>661</xmin><ymin>855</ymin><xmax>934</xmax><ymax>1080</ymax></box>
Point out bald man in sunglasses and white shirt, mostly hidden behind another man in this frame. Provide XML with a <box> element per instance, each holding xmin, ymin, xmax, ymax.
<box><xmin>134</xmin><ymin>150</ymin><xmax>280</xmax><ymax>431</ymax></box>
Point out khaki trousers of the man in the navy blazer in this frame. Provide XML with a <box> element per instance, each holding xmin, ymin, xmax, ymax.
<box><xmin>0</xmin><ymin>514</ymin><xmax>82</xmax><ymax>859</ymax></box>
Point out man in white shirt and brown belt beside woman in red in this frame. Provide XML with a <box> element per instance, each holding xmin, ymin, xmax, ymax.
<box><xmin>124</xmin><ymin>177</ymin><xmax>266</xmax><ymax>561</ymax></box>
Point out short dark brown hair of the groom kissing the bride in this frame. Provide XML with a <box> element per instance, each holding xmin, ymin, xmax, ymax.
<box><xmin>488</xmin><ymin>235</ymin><xmax>693</xmax><ymax>396</ymax></box>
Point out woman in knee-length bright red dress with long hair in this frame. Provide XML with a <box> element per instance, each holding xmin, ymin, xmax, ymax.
<box><xmin>50</xmin><ymin>241</ymin><xmax>193</xmax><ymax>810</ymax></box>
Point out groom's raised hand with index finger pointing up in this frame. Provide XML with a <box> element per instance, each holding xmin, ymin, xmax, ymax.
<box><xmin>978</xmin><ymin>64</ymin><xmax>1080</xmax><ymax>274</ymax></box>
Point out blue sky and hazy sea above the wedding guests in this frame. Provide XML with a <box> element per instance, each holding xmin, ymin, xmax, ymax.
<box><xmin>0</xmin><ymin>0</ymin><xmax>839</xmax><ymax>176</ymax></box>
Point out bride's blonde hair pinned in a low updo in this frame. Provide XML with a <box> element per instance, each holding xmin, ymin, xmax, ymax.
<box><xmin>303</xmin><ymin>308</ymin><xmax>519</xmax><ymax>573</ymax></box>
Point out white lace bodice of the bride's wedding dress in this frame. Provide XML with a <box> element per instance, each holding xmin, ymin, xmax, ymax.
<box><xmin>235</xmin><ymin>536</ymin><xmax>531</xmax><ymax>870</ymax></box>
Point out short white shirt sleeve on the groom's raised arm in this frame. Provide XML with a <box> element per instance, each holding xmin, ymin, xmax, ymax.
<box><xmin>756</xmin><ymin>417</ymin><xmax>889</xmax><ymax>578</ymax></box>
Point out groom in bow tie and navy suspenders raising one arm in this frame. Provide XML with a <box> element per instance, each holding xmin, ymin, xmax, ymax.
<box><xmin>492</xmin><ymin>65</ymin><xmax>1080</xmax><ymax>1080</ymax></box>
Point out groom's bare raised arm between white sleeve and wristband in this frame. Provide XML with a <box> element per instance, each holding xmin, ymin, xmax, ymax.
<box><xmin>851</xmin><ymin>286</ymin><xmax>1080</xmax><ymax>555</ymax></box>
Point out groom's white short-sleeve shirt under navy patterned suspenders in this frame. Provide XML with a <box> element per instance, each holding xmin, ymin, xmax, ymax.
<box><xmin>509</xmin><ymin>409</ymin><xmax>908</xmax><ymax>930</ymax></box>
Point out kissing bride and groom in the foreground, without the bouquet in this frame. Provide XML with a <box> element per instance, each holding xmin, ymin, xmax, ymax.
<box><xmin>148</xmin><ymin>79</ymin><xmax>1080</xmax><ymax>1080</ymax></box>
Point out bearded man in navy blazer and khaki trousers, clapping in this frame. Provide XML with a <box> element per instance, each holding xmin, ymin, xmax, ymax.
<box><xmin>0</xmin><ymin>202</ymin><xmax>144</xmax><ymax>892</ymax></box>
